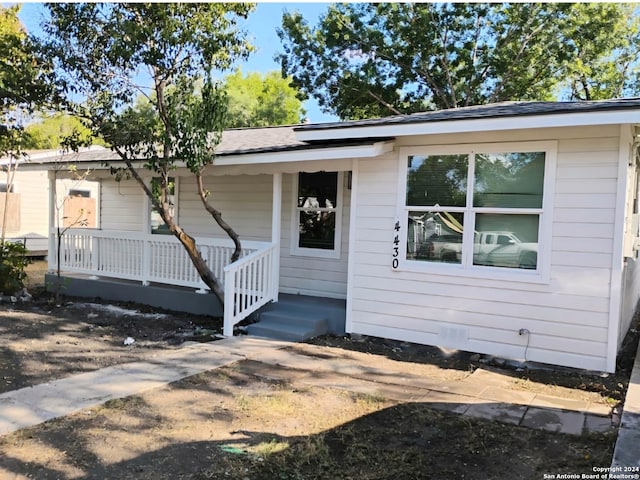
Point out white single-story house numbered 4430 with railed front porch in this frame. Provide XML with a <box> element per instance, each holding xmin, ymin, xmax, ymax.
<box><xmin>17</xmin><ymin>98</ymin><xmax>640</xmax><ymax>372</ymax></box>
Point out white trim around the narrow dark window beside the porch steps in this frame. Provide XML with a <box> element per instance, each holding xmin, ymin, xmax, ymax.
<box><xmin>290</xmin><ymin>172</ymin><xmax>344</xmax><ymax>260</ymax></box>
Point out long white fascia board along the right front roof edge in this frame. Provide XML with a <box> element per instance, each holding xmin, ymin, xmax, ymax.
<box><xmin>295</xmin><ymin>110</ymin><xmax>640</xmax><ymax>142</ymax></box>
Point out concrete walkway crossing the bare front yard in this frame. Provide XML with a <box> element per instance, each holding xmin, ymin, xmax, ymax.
<box><xmin>0</xmin><ymin>336</ymin><xmax>640</xmax><ymax>466</ymax></box>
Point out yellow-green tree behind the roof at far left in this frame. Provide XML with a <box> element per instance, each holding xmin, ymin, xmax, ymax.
<box><xmin>23</xmin><ymin>112</ymin><xmax>104</xmax><ymax>150</ymax></box>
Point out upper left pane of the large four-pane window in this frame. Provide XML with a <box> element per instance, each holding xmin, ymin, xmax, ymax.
<box><xmin>406</xmin><ymin>155</ymin><xmax>469</xmax><ymax>207</ymax></box>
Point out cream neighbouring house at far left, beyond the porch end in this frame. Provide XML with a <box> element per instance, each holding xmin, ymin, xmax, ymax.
<box><xmin>0</xmin><ymin>147</ymin><xmax>98</xmax><ymax>256</ymax></box>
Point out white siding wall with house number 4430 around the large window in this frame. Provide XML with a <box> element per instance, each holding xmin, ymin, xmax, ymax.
<box><xmin>349</xmin><ymin>126</ymin><xmax>619</xmax><ymax>370</ymax></box>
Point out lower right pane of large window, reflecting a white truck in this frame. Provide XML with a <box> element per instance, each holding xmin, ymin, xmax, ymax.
<box><xmin>473</xmin><ymin>213</ymin><xmax>540</xmax><ymax>269</ymax></box>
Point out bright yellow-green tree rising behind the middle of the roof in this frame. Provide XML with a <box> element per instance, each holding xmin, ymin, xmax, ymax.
<box><xmin>224</xmin><ymin>69</ymin><xmax>306</xmax><ymax>128</ymax></box>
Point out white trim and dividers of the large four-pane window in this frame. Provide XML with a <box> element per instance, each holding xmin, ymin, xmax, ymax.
<box><xmin>390</xmin><ymin>141</ymin><xmax>558</xmax><ymax>284</ymax></box>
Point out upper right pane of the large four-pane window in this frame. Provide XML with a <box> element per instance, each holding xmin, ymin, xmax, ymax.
<box><xmin>473</xmin><ymin>152</ymin><xmax>545</xmax><ymax>208</ymax></box>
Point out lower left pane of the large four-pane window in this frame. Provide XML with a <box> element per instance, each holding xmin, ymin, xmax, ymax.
<box><xmin>407</xmin><ymin>211</ymin><xmax>464</xmax><ymax>263</ymax></box>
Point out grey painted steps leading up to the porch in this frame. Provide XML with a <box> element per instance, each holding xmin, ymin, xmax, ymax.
<box><xmin>247</xmin><ymin>308</ymin><xmax>329</xmax><ymax>342</ymax></box>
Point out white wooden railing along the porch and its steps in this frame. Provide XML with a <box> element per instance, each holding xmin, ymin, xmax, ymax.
<box><xmin>49</xmin><ymin>228</ymin><xmax>278</xmax><ymax>336</ymax></box>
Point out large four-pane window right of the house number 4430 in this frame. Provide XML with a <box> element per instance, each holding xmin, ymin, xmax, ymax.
<box><xmin>394</xmin><ymin>142</ymin><xmax>555</xmax><ymax>272</ymax></box>
